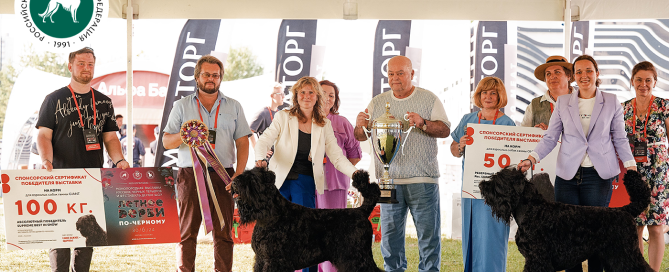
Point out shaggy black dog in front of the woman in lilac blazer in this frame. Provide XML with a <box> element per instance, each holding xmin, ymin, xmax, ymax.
<box><xmin>479</xmin><ymin>167</ymin><xmax>653</xmax><ymax>272</ymax></box>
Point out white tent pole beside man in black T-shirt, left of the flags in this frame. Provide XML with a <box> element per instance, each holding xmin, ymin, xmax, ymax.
<box><xmin>125</xmin><ymin>0</ymin><xmax>135</xmax><ymax>167</ymax></box>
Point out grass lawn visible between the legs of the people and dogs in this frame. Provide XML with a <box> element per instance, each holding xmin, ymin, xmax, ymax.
<box><xmin>0</xmin><ymin>198</ymin><xmax>669</xmax><ymax>272</ymax></box>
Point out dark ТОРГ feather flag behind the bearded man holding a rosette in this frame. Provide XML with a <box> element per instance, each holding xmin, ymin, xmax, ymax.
<box><xmin>154</xmin><ymin>20</ymin><xmax>221</xmax><ymax>167</ymax></box>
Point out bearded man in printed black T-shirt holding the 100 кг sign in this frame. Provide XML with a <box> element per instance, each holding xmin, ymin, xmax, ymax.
<box><xmin>35</xmin><ymin>47</ymin><xmax>129</xmax><ymax>272</ymax></box>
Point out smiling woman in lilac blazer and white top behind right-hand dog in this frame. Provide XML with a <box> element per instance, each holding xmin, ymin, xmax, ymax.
<box><xmin>518</xmin><ymin>55</ymin><xmax>637</xmax><ymax>272</ymax></box>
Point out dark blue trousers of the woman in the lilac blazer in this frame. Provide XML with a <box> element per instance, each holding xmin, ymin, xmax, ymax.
<box><xmin>555</xmin><ymin>167</ymin><xmax>618</xmax><ymax>272</ymax></box>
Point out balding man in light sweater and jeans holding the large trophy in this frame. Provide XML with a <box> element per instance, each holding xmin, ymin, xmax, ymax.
<box><xmin>355</xmin><ymin>56</ymin><xmax>451</xmax><ymax>271</ymax></box>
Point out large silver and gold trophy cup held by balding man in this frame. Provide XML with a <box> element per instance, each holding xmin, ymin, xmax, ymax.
<box><xmin>363</xmin><ymin>103</ymin><xmax>414</xmax><ymax>203</ymax></box>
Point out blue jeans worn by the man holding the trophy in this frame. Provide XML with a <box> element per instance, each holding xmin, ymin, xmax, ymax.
<box><xmin>381</xmin><ymin>183</ymin><xmax>441</xmax><ymax>272</ymax></box>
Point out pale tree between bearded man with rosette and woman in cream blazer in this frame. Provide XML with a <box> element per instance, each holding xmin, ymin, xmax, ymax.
<box><xmin>223</xmin><ymin>47</ymin><xmax>264</xmax><ymax>81</ymax></box>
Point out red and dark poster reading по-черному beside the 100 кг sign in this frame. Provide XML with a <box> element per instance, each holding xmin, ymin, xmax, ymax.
<box><xmin>100</xmin><ymin>167</ymin><xmax>180</xmax><ymax>246</ymax></box>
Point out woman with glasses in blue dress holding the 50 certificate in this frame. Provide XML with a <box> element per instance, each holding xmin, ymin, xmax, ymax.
<box><xmin>451</xmin><ymin>77</ymin><xmax>515</xmax><ymax>272</ymax></box>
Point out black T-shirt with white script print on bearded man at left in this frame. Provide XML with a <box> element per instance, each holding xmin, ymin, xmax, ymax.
<box><xmin>35</xmin><ymin>86</ymin><xmax>118</xmax><ymax>169</ymax></box>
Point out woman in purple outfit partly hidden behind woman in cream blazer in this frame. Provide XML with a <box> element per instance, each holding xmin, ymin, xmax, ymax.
<box><xmin>316</xmin><ymin>80</ymin><xmax>362</xmax><ymax>272</ymax></box>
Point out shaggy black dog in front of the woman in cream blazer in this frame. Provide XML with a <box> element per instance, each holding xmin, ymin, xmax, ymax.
<box><xmin>232</xmin><ymin>167</ymin><xmax>382</xmax><ymax>272</ymax></box>
